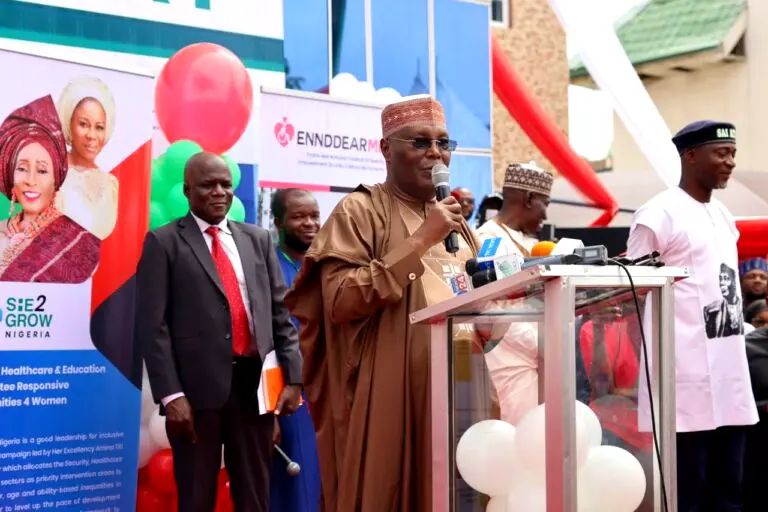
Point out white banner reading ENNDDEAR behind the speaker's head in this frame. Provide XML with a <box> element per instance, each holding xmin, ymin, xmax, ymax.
<box><xmin>258</xmin><ymin>88</ymin><xmax>386</xmax><ymax>192</ymax></box>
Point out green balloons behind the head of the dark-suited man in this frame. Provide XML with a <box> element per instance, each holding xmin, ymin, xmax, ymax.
<box><xmin>149</xmin><ymin>140</ymin><xmax>245</xmax><ymax>229</ymax></box>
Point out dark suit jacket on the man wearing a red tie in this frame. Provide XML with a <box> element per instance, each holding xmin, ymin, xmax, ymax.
<box><xmin>136</xmin><ymin>214</ymin><xmax>302</xmax><ymax>410</ymax></box>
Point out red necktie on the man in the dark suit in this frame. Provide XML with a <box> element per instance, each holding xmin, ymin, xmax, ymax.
<box><xmin>205</xmin><ymin>226</ymin><xmax>251</xmax><ymax>355</ymax></box>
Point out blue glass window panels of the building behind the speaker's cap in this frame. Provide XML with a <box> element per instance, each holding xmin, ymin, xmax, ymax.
<box><xmin>284</xmin><ymin>0</ymin><xmax>492</xmax><ymax>205</ymax></box>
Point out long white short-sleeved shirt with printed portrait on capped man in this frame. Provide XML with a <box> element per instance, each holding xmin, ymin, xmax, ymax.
<box><xmin>627</xmin><ymin>187</ymin><xmax>758</xmax><ymax>433</ymax></box>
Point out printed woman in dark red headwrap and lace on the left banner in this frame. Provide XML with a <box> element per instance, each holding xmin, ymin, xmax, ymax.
<box><xmin>0</xmin><ymin>96</ymin><xmax>100</xmax><ymax>284</ymax></box>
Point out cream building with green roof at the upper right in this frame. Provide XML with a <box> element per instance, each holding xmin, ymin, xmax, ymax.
<box><xmin>571</xmin><ymin>0</ymin><xmax>768</xmax><ymax>172</ymax></box>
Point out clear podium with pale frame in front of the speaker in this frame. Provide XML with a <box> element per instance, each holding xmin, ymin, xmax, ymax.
<box><xmin>410</xmin><ymin>265</ymin><xmax>688</xmax><ymax>512</ymax></box>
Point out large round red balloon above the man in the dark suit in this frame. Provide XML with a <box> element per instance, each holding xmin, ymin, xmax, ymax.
<box><xmin>155</xmin><ymin>43</ymin><xmax>253</xmax><ymax>154</ymax></box>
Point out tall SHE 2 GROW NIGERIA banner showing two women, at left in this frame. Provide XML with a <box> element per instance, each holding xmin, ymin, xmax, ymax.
<box><xmin>0</xmin><ymin>49</ymin><xmax>154</xmax><ymax>512</ymax></box>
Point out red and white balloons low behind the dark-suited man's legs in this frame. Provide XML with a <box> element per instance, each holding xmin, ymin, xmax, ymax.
<box><xmin>136</xmin><ymin>370</ymin><xmax>234</xmax><ymax>512</ymax></box>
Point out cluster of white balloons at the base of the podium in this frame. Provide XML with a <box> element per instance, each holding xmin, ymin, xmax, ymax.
<box><xmin>456</xmin><ymin>402</ymin><xmax>646</xmax><ymax>512</ymax></box>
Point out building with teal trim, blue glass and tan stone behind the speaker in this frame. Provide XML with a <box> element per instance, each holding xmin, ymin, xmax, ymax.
<box><xmin>0</xmin><ymin>0</ymin><xmax>568</xmax><ymax>218</ymax></box>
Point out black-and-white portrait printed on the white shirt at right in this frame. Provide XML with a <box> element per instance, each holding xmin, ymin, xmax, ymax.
<box><xmin>704</xmin><ymin>263</ymin><xmax>744</xmax><ymax>339</ymax></box>
